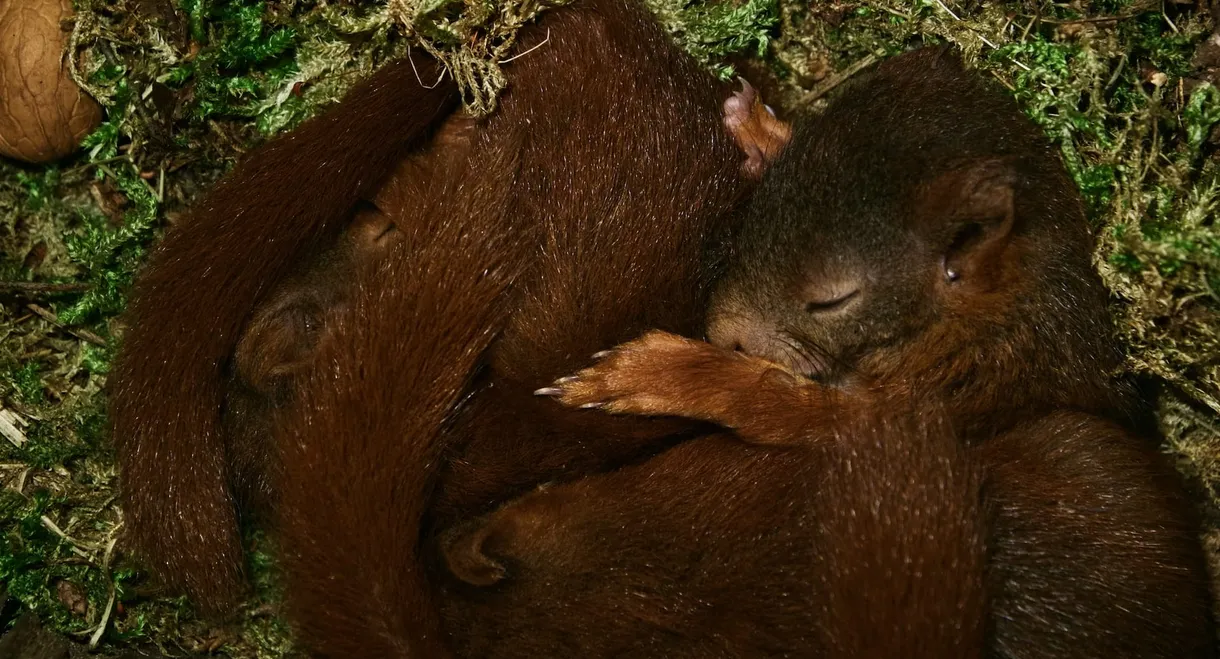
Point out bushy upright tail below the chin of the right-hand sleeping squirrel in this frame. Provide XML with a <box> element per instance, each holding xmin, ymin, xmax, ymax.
<box><xmin>815</xmin><ymin>414</ymin><xmax>987</xmax><ymax>659</ymax></box>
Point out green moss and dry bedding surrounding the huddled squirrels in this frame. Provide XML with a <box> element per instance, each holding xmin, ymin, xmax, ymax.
<box><xmin>0</xmin><ymin>0</ymin><xmax>1220</xmax><ymax>658</ymax></box>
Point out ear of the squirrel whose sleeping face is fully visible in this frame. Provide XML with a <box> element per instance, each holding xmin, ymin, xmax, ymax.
<box><xmin>924</xmin><ymin>159</ymin><xmax>1016</xmax><ymax>283</ymax></box>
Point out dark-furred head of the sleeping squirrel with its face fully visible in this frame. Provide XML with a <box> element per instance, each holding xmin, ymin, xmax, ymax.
<box><xmin>549</xmin><ymin>43</ymin><xmax>1146</xmax><ymax>436</ymax></box>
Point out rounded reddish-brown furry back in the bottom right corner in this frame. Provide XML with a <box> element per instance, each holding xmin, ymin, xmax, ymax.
<box><xmin>975</xmin><ymin>412</ymin><xmax>1215</xmax><ymax>659</ymax></box>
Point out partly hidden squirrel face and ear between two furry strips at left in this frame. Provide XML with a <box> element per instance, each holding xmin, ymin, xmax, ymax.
<box><xmin>222</xmin><ymin>113</ymin><xmax>473</xmax><ymax>519</ymax></box>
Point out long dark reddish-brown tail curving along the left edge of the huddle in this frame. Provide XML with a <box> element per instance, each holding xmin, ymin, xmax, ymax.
<box><xmin>111</xmin><ymin>55</ymin><xmax>458</xmax><ymax>611</ymax></box>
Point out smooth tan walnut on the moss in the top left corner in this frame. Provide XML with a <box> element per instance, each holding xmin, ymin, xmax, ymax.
<box><xmin>0</xmin><ymin>0</ymin><xmax>101</xmax><ymax>164</ymax></box>
